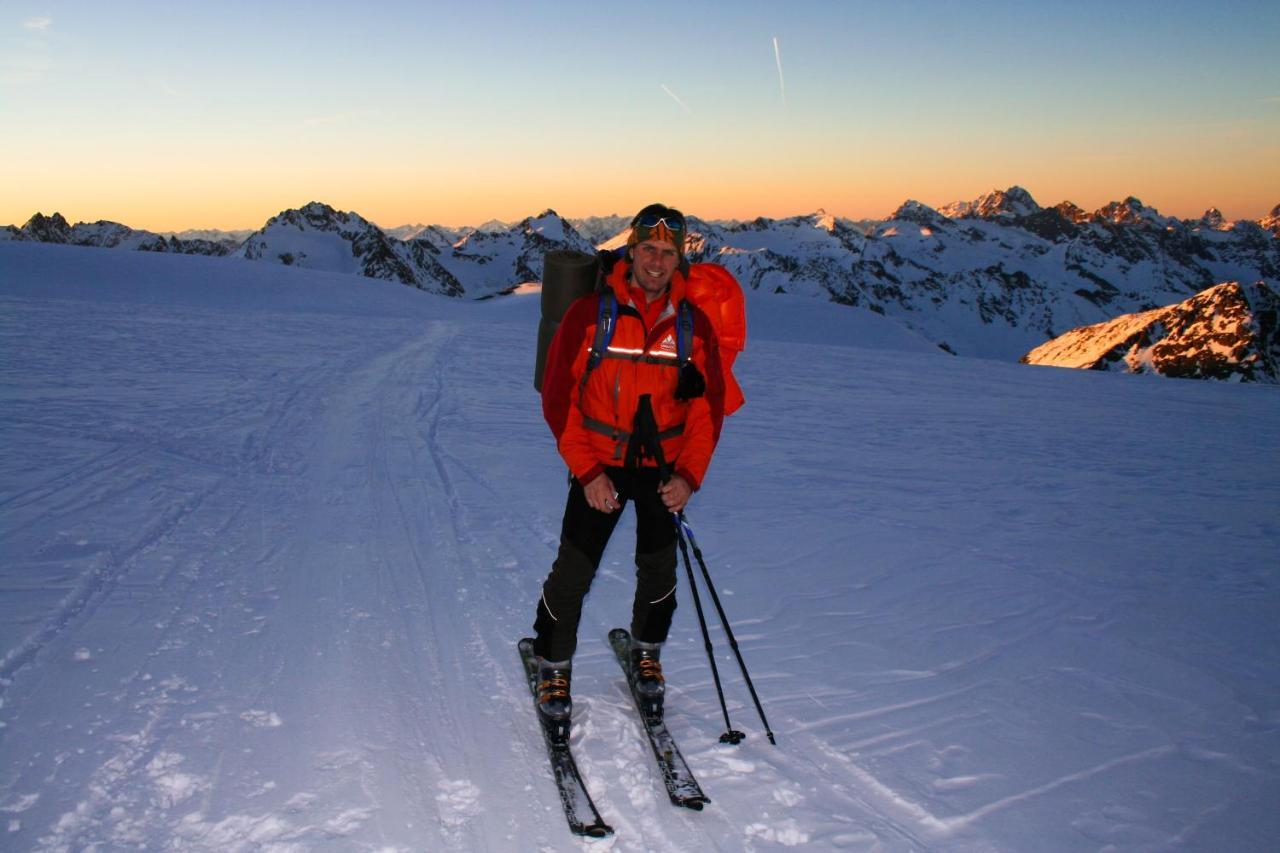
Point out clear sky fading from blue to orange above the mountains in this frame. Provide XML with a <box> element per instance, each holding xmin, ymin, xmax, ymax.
<box><xmin>0</xmin><ymin>0</ymin><xmax>1280</xmax><ymax>231</ymax></box>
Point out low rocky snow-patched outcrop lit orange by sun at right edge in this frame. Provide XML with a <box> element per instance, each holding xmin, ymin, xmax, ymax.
<box><xmin>1023</xmin><ymin>282</ymin><xmax>1280</xmax><ymax>384</ymax></box>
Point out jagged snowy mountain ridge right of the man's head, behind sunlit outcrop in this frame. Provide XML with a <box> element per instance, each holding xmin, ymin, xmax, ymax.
<box><xmin>692</xmin><ymin>187</ymin><xmax>1280</xmax><ymax>359</ymax></box>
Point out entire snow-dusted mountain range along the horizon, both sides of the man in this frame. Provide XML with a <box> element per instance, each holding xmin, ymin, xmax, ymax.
<box><xmin>0</xmin><ymin>186</ymin><xmax>1280</xmax><ymax>380</ymax></box>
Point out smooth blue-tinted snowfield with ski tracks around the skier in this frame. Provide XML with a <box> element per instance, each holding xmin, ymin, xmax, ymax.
<box><xmin>0</xmin><ymin>235</ymin><xmax>1280</xmax><ymax>850</ymax></box>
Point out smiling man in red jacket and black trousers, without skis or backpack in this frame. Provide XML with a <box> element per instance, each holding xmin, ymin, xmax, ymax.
<box><xmin>534</xmin><ymin>205</ymin><xmax>724</xmax><ymax>724</ymax></box>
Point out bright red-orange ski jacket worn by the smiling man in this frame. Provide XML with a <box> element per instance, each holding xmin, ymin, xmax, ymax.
<box><xmin>543</xmin><ymin>261</ymin><xmax>724</xmax><ymax>489</ymax></box>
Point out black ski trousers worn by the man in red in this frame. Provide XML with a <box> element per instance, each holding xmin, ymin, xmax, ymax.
<box><xmin>534</xmin><ymin>467</ymin><xmax>676</xmax><ymax>661</ymax></box>
